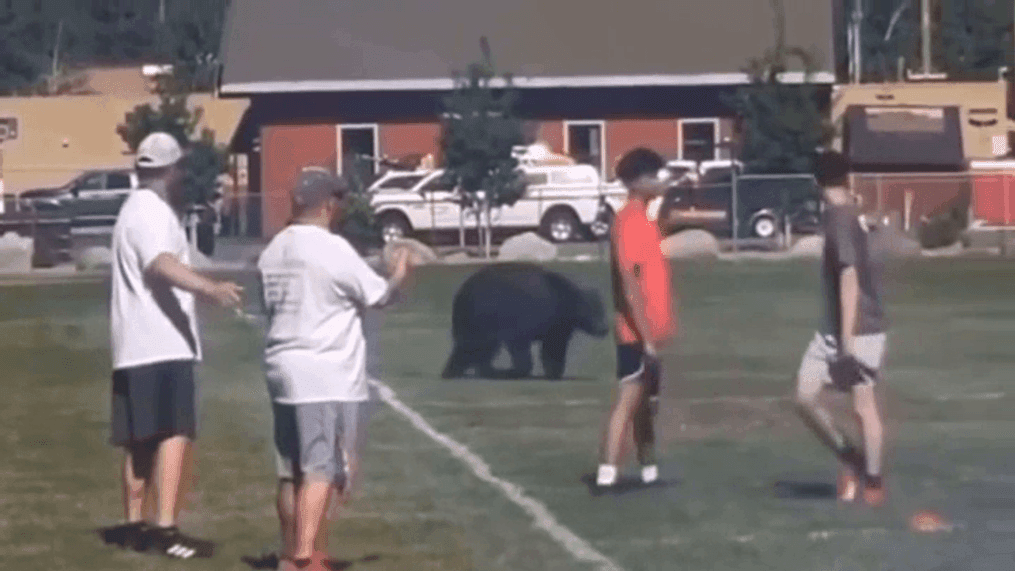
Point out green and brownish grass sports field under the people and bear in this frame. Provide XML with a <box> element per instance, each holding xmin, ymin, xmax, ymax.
<box><xmin>0</xmin><ymin>261</ymin><xmax>1015</xmax><ymax>571</ymax></box>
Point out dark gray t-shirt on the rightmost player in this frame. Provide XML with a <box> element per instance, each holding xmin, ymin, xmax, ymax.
<box><xmin>821</xmin><ymin>205</ymin><xmax>888</xmax><ymax>339</ymax></box>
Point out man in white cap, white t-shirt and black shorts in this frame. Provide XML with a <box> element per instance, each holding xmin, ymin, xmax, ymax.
<box><xmin>103</xmin><ymin>133</ymin><xmax>243</xmax><ymax>559</ymax></box>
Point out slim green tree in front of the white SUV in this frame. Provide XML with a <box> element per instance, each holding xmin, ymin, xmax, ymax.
<box><xmin>441</xmin><ymin>37</ymin><xmax>525</xmax><ymax>254</ymax></box>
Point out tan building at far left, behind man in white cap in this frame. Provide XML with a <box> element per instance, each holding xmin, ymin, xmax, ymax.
<box><xmin>0</xmin><ymin>67</ymin><xmax>249</xmax><ymax>196</ymax></box>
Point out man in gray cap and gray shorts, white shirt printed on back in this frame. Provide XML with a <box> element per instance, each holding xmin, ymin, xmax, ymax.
<box><xmin>258</xmin><ymin>167</ymin><xmax>409</xmax><ymax>570</ymax></box>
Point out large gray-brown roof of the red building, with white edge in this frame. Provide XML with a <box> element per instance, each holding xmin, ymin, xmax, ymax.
<box><xmin>222</xmin><ymin>0</ymin><xmax>833</xmax><ymax>93</ymax></box>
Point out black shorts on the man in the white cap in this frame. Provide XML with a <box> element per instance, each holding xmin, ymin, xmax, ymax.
<box><xmin>110</xmin><ymin>360</ymin><xmax>197</xmax><ymax>446</ymax></box>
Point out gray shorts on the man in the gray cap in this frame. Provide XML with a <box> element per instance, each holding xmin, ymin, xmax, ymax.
<box><xmin>271</xmin><ymin>402</ymin><xmax>365</xmax><ymax>486</ymax></box>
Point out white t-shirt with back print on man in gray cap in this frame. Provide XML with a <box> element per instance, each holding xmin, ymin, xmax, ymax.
<box><xmin>258</xmin><ymin>224</ymin><xmax>388</xmax><ymax>405</ymax></box>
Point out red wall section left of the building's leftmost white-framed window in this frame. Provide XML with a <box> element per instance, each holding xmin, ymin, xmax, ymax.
<box><xmin>261</xmin><ymin>125</ymin><xmax>338</xmax><ymax>238</ymax></box>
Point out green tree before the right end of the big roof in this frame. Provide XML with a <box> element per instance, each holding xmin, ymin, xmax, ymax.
<box><xmin>727</xmin><ymin>0</ymin><xmax>834</xmax><ymax>173</ymax></box>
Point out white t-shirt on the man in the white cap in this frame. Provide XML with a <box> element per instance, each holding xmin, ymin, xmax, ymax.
<box><xmin>110</xmin><ymin>189</ymin><xmax>201</xmax><ymax>369</ymax></box>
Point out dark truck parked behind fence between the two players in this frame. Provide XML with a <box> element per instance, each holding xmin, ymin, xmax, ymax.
<box><xmin>659</xmin><ymin>166</ymin><xmax>821</xmax><ymax>238</ymax></box>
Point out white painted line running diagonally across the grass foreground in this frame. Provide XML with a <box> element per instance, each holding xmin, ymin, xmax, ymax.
<box><xmin>370</xmin><ymin>379</ymin><xmax>623</xmax><ymax>571</ymax></box>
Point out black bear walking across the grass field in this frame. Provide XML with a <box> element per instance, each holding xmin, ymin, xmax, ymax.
<box><xmin>444</xmin><ymin>263</ymin><xmax>609</xmax><ymax>379</ymax></box>
